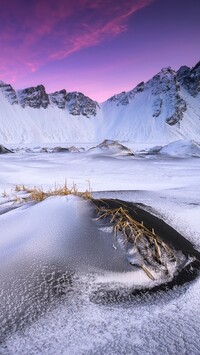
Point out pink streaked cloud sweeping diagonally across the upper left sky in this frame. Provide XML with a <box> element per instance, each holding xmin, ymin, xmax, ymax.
<box><xmin>0</xmin><ymin>0</ymin><xmax>153</xmax><ymax>83</ymax></box>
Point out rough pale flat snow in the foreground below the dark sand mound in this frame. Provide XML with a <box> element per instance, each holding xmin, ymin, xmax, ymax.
<box><xmin>2</xmin><ymin>281</ymin><xmax>200</xmax><ymax>355</ymax></box>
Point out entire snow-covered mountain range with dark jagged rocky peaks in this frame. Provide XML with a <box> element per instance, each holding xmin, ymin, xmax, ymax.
<box><xmin>0</xmin><ymin>62</ymin><xmax>200</xmax><ymax>144</ymax></box>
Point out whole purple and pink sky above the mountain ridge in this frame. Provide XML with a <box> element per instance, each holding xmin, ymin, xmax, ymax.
<box><xmin>0</xmin><ymin>0</ymin><xmax>200</xmax><ymax>101</ymax></box>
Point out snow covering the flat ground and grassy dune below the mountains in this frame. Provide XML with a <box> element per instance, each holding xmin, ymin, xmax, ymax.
<box><xmin>0</xmin><ymin>146</ymin><xmax>200</xmax><ymax>355</ymax></box>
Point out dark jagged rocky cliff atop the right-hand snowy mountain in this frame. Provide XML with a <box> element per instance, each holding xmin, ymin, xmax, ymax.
<box><xmin>108</xmin><ymin>62</ymin><xmax>193</xmax><ymax>125</ymax></box>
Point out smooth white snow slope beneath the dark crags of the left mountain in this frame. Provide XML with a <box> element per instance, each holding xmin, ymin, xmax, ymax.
<box><xmin>0</xmin><ymin>92</ymin><xmax>101</xmax><ymax>145</ymax></box>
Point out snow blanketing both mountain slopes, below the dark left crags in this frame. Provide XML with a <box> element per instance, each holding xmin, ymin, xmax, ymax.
<box><xmin>0</xmin><ymin>76</ymin><xmax>200</xmax><ymax>145</ymax></box>
